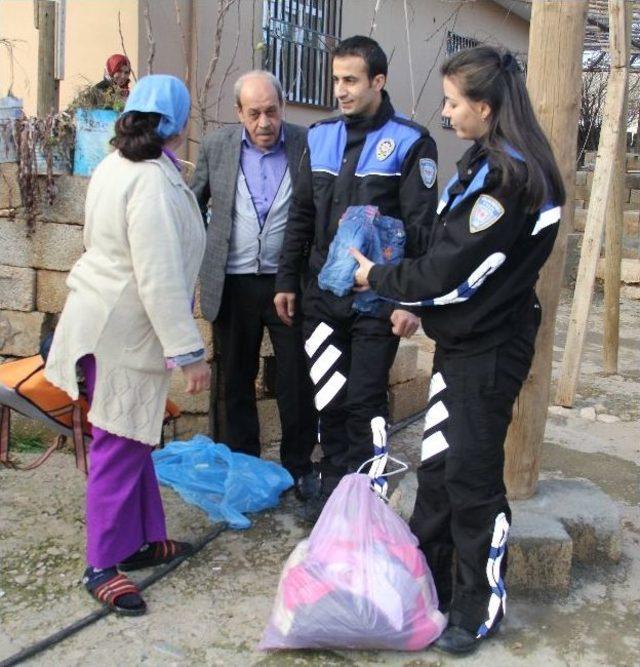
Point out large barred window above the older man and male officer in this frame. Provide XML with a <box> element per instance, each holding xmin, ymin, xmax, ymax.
<box><xmin>263</xmin><ymin>0</ymin><xmax>342</xmax><ymax>109</ymax></box>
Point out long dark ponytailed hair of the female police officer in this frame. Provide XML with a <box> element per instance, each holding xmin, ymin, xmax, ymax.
<box><xmin>440</xmin><ymin>46</ymin><xmax>565</xmax><ymax>211</ymax></box>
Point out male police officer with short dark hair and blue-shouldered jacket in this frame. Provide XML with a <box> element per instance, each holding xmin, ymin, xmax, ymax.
<box><xmin>274</xmin><ymin>36</ymin><xmax>438</xmax><ymax>521</ymax></box>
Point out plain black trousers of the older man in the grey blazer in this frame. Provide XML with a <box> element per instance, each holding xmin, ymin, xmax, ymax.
<box><xmin>213</xmin><ymin>275</ymin><xmax>318</xmax><ymax>479</ymax></box>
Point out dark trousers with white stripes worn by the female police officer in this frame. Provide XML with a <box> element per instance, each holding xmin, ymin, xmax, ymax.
<box><xmin>410</xmin><ymin>307</ymin><xmax>539</xmax><ymax>635</ymax></box>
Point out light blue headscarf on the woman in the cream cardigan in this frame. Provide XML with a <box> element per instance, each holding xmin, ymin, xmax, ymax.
<box><xmin>123</xmin><ymin>74</ymin><xmax>191</xmax><ymax>139</ymax></box>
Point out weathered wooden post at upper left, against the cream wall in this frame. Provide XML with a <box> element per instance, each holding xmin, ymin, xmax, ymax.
<box><xmin>36</xmin><ymin>0</ymin><xmax>59</xmax><ymax>118</ymax></box>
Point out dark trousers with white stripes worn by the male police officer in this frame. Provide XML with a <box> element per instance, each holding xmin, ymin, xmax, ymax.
<box><xmin>303</xmin><ymin>285</ymin><xmax>400</xmax><ymax>480</ymax></box>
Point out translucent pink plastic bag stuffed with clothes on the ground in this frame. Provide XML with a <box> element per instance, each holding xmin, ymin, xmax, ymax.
<box><xmin>259</xmin><ymin>474</ymin><xmax>446</xmax><ymax>651</ymax></box>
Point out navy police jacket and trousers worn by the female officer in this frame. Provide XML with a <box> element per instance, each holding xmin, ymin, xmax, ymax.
<box><xmin>369</xmin><ymin>144</ymin><xmax>560</xmax><ymax>637</ymax></box>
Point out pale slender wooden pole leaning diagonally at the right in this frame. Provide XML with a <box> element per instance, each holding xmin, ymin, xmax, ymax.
<box><xmin>556</xmin><ymin>0</ymin><xmax>631</xmax><ymax>407</ymax></box>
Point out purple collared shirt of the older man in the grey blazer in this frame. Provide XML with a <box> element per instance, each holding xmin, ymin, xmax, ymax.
<box><xmin>240</xmin><ymin>126</ymin><xmax>287</xmax><ymax>227</ymax></box>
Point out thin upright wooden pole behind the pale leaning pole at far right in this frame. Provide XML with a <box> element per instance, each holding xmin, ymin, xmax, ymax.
<box><xmin>602</xmin><ymin>3</ymin><xmax>632</xmax><ymax>373</ymax></box>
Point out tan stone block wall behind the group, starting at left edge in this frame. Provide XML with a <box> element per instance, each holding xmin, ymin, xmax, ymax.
<box><xmin>0</xmin><ymin>164</ymin><xmax>432</xmax><ymax>443</ymax></box>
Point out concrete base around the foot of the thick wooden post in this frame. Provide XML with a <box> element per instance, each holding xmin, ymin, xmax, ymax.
<box><xmin>390</xmin><ymin>473</ymin><xmax>621</xmax><ymax>593</ymax></box>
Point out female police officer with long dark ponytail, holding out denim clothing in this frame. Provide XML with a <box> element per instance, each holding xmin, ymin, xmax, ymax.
<box><xmin>352</xmin><ymin>47</ymin><xmax>565</xmax><ymax>653</ymax></box>
